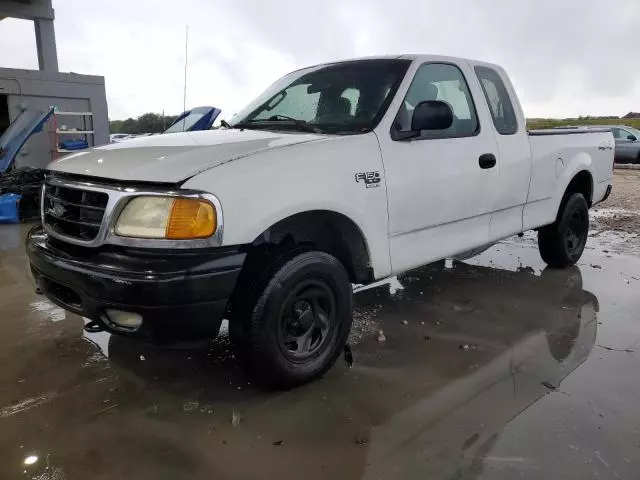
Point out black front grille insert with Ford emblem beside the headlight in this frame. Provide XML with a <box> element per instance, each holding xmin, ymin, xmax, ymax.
<box><xmin>43</xmin><ymin>184</ymin><xmax>109</xmax><ymax>241</ymax></box>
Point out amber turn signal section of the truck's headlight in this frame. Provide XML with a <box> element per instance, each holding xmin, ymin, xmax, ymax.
<box><xmin>165</xmin><ymin>198</ymin><xmax>217</xmax><ymax>240</ymax></box>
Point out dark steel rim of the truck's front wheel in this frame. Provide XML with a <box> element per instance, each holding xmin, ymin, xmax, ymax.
<box><xmin>277</xmin><ymin>279</ymin><xmax>336</xmax><ymax>362</ymax></box>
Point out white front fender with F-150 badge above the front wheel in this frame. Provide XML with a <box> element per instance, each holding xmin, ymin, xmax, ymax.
<box><xmin>179</xmin><ymin>134</ymin><xmax>391</xmax><ymax>278</ymax></box>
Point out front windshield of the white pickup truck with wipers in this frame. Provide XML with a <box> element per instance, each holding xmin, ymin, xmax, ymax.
<box><xmin>230</xmin><ymin>59</ymin><xmax>410</xmax><ymax>134</ymax></box>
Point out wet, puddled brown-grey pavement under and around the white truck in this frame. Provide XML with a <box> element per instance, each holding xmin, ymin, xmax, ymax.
<box><xmin>0</xmin><ymin>226</ymin><xmax>640</xmax><ymax>480</ymax></box>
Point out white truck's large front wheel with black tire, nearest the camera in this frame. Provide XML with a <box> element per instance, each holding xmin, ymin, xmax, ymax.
<box><xmin>229</xmin><ymin>250</ymin><xmax>353</xmax><ymax>388</ymax></box>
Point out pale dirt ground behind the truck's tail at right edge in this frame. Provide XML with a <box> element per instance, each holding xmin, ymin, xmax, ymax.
<box><xmin>592</xmin><ymin>170</ymin><xmax>640</xmax><ymax>234</ymax></box>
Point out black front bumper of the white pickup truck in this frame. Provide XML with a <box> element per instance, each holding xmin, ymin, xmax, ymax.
<box><xmin>26</xmin><ymin>227</ymin><xmax>246</xmax><ymax>344</ymax></box>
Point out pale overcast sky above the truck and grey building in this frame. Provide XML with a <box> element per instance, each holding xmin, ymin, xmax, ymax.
<box><xmin>0</xmin><ymin>0</ymin><xmax>640</xmax><ymax>119</ymax></box>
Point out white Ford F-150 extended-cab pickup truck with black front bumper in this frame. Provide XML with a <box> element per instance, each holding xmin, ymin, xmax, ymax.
<box><xmin>27</xmin><ymin>55</ymin><xmax>614</xmax><ymax>386</ymax></box>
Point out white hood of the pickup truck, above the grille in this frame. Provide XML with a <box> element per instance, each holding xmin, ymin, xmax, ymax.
<box><xmin>47</xmin><ymin>129</ymin><xmax>329</xmax><ymax>183</ymax></box>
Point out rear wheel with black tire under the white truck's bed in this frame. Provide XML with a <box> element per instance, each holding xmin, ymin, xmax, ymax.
<box><xmin>538</xmin><ymin>193</ymin><xmax>589</xmax><ymax>268</ymax></box>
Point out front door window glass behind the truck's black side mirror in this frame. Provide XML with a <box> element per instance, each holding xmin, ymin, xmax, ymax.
<box><xmin>393</xmin><ymin>63</ymin><xmax>479</xmax><ymax>138</ymax></box>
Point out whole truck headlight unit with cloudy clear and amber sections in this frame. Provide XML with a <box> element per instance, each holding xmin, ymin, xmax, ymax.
<box><xmin>115</xmin><ymin>196</ymin><xmax>217</xmax><ymax>240</ymax></box>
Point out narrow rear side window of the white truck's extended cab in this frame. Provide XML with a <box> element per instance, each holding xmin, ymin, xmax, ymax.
<box><xmin>475</xmin><ymin>67</ymin><xmax>518</xmax><ymax>135</ymax></box>
